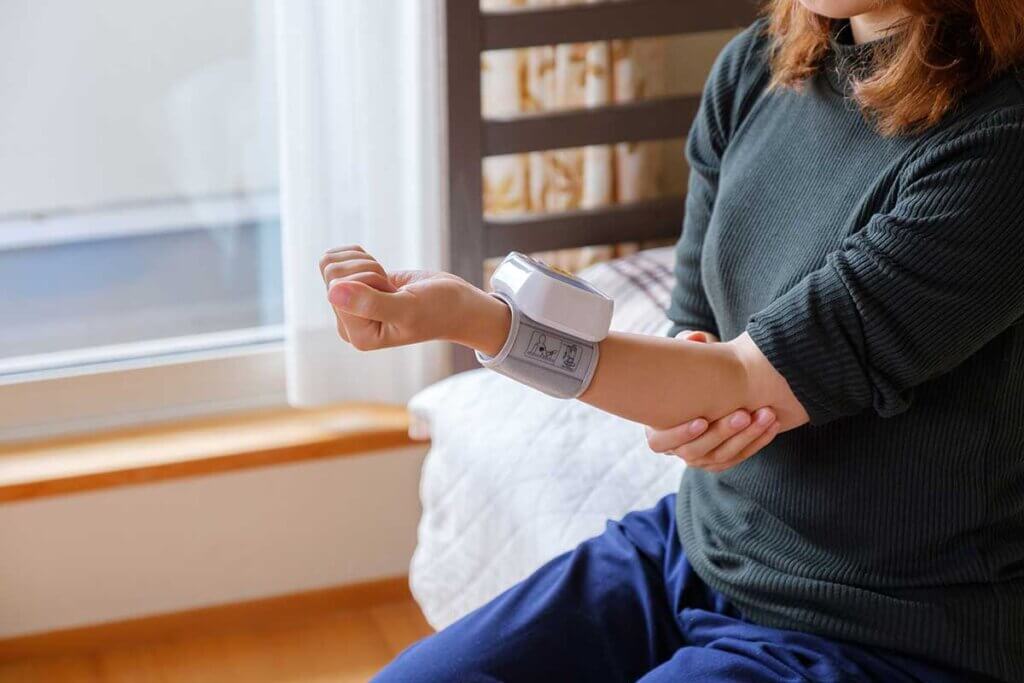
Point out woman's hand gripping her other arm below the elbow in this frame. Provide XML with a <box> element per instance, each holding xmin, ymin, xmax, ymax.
<box><xmin>646</xmin><ymin>332</ymin><xmax>779</xmax><ymax>472</ymax></box>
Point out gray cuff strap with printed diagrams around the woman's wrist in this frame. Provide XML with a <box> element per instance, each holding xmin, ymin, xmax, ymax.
<box><xmin>476</xmin><ymin>293</ymin><xmax>598</xmax><ymax>398</ymax></box>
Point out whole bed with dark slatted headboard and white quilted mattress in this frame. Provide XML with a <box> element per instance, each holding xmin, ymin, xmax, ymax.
<box><xmin>410</xmin><ymin>0</ymin><xmax>756</xmax><ymax>628</ymax></box>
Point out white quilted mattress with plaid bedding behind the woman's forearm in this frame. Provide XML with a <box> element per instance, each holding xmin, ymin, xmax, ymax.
<box><xmin>410</xmin><ymin>248</ymin><xmax>684</xmax><ymax>629</ymax></box>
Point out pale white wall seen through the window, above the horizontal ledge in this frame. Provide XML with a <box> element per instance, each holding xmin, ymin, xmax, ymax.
<box><xmin>0</xmin><ymin>0</ymin><xmax>276</xmax><ymax>217</ymax></box>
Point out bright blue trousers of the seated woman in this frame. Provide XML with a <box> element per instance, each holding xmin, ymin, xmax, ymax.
<box><xmin>375</xmin><ymin>496</ymin><xmax>974</xmax><ymax>683</ymax></box>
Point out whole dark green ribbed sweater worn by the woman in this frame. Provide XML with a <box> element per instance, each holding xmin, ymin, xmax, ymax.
<box><xmin>670</xmin><ymin>18</ymin><xmax>1024</xmax><ymax>681</ymax></box>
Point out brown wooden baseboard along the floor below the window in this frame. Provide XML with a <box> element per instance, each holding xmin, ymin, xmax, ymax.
<box><xmin>0</xmin><ymin>577</ymin><xmax>412</xmax><ymax>661</ymax></box>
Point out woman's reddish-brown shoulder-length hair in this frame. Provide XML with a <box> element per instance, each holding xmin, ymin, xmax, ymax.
<box><xmin>766</xmin><ymin>0</ymin><xmax>1024</xmax><ymax>136</ymax></box>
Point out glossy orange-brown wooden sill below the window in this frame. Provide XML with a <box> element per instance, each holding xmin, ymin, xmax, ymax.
<box><xmin>0</xmin><ymin>403</ymin><xmax>416</xmax><ymax>503</ymax></box>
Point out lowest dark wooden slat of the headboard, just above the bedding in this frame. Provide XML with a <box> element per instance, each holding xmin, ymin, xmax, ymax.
<box><xmin>484</xmin><ymin>197</ymin><xmax>685</xmax><ymax>257</ymax></box>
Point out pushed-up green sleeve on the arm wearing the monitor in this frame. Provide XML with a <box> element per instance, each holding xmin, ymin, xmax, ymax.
<box><xmin>746</xmin><ymin>111</ymin><xmax>1024</xmax><ymax>424</ymax></box>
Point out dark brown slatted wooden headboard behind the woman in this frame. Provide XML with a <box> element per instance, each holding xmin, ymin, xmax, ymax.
<box><xmin>445</xmin><ymin>0</ymin><xmax>757</xmax><ymax>370</ymax></box>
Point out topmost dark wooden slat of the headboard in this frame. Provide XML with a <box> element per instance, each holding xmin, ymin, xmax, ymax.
<box><xmin>481</xmin><ymin>0</ymin><xmax>757</xmax><ymax>50</ymax></box>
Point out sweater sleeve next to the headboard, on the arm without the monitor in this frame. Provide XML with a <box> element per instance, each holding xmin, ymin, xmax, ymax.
<box><xmin>668</xmin><ymin>22</ymin><xmax>765</xmax><ymax>337</ymax></box>
